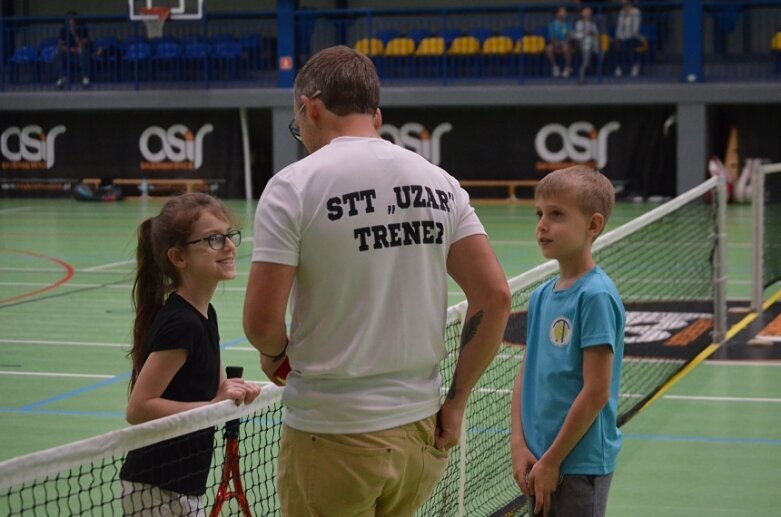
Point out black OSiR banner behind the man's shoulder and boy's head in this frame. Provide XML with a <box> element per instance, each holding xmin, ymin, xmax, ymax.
<box><xmin>380</xmin><ymin>106</ymin><xmax>675</xmax><ymax>196</ymax></box>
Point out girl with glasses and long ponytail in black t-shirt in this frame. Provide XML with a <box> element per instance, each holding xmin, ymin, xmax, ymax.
<box><xmin>120</xmin><ymin>194</ymin><xmax>260</xmax><ymax>515</ymax></box>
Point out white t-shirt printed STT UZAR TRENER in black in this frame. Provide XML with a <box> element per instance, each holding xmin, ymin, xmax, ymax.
<box><xmin>252</xmin><ymin>137</ymin><xmax>485</xmax><ymax>433</ymax></box>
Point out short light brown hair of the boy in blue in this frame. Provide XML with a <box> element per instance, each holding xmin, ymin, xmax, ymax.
<box><xmin>534</xmin><ymin>165</ymin><xmax>616</xmax><ymax>223</ymax></box>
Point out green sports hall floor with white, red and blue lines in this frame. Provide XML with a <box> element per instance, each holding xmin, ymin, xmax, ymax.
<box><xmin>0</xmin><ymin>199</ymin><xmax>781</xmax><ymax>517</ymax></box>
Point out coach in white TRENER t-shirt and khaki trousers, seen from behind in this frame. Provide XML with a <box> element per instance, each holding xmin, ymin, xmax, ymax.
<box><xmin>244</xmin><ymin>46</ymin><xmax>510</xmax><ymax>517</ymax></box>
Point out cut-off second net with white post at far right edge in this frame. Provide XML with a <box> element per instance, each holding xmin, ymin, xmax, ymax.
<box><xmin>751</xmin><ymin>163</ymin><xmax>781</xmax><ymax>311</ymax></box>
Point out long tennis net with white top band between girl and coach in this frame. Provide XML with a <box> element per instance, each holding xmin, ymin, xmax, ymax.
<box><xmin>0</xmin><ymin>179</ymin><xmax>726</xmax><ymax>517</ymax></box>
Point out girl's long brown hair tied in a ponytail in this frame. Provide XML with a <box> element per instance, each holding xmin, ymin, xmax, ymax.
<box><xmin>128</xmin><ymin>194</ymin><xmax>235</xmax><ymax>390</ymax></box>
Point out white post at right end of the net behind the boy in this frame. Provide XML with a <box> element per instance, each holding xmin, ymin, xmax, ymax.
<box><xmin>713</xmin><ymin>172</ymin><xmax>727</xmax><ymax>344</ymax></box>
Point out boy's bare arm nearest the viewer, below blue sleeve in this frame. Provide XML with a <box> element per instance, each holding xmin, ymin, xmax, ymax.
<box><xmin>529</xmin><ymin>345</ymin><xmax>613</xmax><ymax>513</ymax></box>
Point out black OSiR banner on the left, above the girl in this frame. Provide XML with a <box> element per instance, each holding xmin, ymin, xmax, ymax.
<box><xmin>0</xmin><ymin>110</ymin><xmax>243</xmax><ymax>195</ymax></box>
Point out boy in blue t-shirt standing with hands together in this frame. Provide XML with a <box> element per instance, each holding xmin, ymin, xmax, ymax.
<box><xmin>511</xmin><ymin>165</ymin><xmax>626</xmax><ymax>517</ymax></box>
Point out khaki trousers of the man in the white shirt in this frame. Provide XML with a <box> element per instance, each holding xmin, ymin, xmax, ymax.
<box><xmin>278</xmin><ymin>415</ymin><xmax>448</xmax><ymax>517</ymax></box>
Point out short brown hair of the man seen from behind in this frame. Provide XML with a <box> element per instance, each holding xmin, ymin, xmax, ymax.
<box><xmin>293</xmin><ymin>45</ymin><xmax>380</xmax><ymax>117</ymax></box>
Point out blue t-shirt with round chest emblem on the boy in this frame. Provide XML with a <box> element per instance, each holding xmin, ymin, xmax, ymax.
<box><xmin>521</xmin><ymin>267</ymin><xmax>626</xmax><ymax>475</ymax></box>
